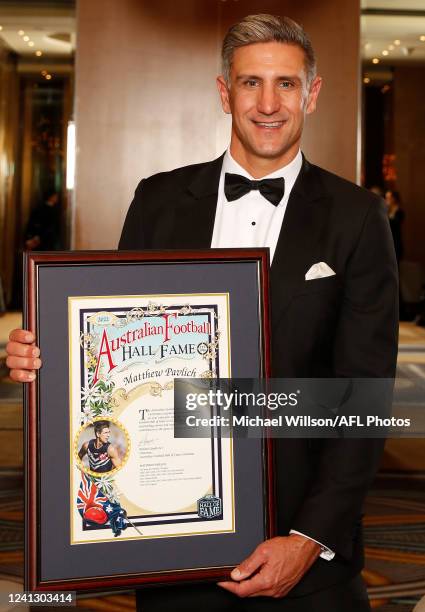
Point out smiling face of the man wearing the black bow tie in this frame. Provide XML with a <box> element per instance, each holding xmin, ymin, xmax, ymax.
<box><xmin>217</xmin><ymin>42</ymin><xmax>321</xmax><ymax>173</ymax></box>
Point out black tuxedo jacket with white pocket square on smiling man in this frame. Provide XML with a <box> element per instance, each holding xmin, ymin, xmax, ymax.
<box><xmin>119</xmin><ymin>157</ymin><xmax>398</xmax><ymax>596</ymax></box>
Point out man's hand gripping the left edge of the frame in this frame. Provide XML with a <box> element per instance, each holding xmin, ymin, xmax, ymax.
<box><xmin>6</xmin><ymin>329</ymin><xmax>41</xmax><ymax>382</ymax></box>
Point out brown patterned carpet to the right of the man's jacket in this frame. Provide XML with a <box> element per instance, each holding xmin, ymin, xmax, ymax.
<box><xmin>364</xmin><ymin>323</ymin><xmax>425</xmax><ymax>612</ymax></box>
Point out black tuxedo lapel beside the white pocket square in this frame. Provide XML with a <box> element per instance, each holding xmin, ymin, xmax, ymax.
<box><xmin>270</xmin><ymin>159</ymin><xmax>330</xmax><ymax>322</ymax></box>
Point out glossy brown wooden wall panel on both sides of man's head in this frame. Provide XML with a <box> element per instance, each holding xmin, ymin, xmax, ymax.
<box><xmin>73</xmin><ymin>0</ymin><xmax>359</xmax><ymax>249</ymax></box>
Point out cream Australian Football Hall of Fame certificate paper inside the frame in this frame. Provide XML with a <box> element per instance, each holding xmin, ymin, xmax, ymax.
<box><xmin>68</xmin><ymin>293</ymin><xmax>235</xmax><ymax>544</ymax></box>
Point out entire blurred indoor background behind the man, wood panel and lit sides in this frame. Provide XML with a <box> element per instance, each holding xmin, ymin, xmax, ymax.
<box><xmin>0</xmin><ymin>0</ymin><xmax>425</xmax><ymax>304</ymax></box>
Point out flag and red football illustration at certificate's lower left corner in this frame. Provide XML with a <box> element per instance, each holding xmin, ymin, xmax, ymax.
<box><xmin>77</xmin><ymin>472</ymin><xmax>127</xmax><ymax>537</ymax></box>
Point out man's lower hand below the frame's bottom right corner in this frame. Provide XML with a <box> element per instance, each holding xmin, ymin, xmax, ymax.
<box><xmin>218</xmin><ymin>534</ymin><xmax>320</xmax><ymax>598</ymax></box>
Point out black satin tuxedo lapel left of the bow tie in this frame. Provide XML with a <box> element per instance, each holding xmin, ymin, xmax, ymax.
<box><xmin>167</xmin><ymin>155</ymin><xmax>223</xmax><ymax>249</ymax></box>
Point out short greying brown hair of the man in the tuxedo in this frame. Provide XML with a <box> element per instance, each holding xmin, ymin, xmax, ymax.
<box><xmin>221</xmin><ymin>13</ymin><xmax>316</xmax><ymax>84</ymax></box>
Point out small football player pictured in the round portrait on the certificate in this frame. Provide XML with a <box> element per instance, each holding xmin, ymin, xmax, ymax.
<box><xmin>78</xmin><ymin>421</ymin><xmax>121</xmax><ymax>474</ymax></box>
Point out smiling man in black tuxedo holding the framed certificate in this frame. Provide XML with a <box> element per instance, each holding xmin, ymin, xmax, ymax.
<box><xmin>8</xmin><ymin>15</ymin><xmax>398</xmax><ymax>612</ymax></box>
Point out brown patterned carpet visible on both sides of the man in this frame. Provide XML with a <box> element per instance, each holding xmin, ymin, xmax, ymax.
<box><xmin>0</xmin><ymin>317</ymin><xmax>425</xmax><ymax>612</ymax></box>
